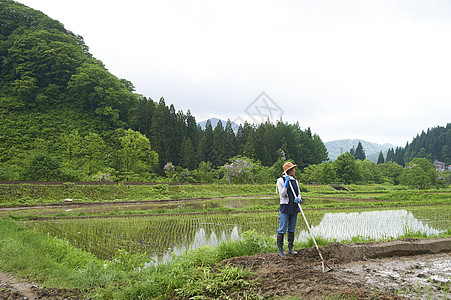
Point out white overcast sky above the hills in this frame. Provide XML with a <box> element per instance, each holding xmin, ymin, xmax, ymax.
<box><xmin>19</xmin><ymin>0</ymin><xmax>451</xmax><ymax>146</ymax></box>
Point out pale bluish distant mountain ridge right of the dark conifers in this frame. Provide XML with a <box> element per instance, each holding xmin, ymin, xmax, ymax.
<box><xmin>324</xmin><ymin>139</ymin><xmax>396</xmax><ymax>162</ymax></box>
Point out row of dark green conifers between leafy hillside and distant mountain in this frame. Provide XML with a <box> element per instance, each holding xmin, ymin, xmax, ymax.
<box><xmin>131</xmin><ymin>99</ymin><xmax>328</xmax><ymax>170</ymax></box>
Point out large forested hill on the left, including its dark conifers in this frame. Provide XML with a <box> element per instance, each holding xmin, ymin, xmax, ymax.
<box><xmin>0</xmin><ymin>0</ymin><xmax>327</xmax><ymax>180</ymax></box>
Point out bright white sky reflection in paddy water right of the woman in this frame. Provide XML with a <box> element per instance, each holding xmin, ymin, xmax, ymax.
<box><xmin>297</xmin><ymin>210</ymin><xmax>443</xmax><ymax>241</ymax></box>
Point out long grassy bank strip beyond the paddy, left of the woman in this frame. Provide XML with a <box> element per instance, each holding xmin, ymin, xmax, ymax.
<box><xmin>0</xmin><ymin>183</ymin><xmax>275</xmax><ymax>206</ymax></box>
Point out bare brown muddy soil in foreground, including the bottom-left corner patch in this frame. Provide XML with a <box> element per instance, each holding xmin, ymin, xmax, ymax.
<box><xmin>0</xmin><ymin>238</ymin><xmax>451</xmax><ymax>299</ymax></box>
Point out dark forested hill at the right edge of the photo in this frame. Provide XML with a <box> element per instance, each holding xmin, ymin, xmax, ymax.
<box><xmin>385</xmin><ymin>123</ymin><xmax>451</xmax><ymax>166</ymax></box>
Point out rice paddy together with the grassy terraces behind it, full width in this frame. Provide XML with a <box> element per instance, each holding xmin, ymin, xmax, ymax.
<box><xmin>0</xmin><ymin>185</ymin><xmax>451</xmax><ymax>262</ymax></box>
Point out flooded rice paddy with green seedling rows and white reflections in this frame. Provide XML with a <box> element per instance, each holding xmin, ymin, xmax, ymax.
<box><xmin>25</xmin><ymin>206</ymin><xmax>451</xmax><ymax>261</ymax></box>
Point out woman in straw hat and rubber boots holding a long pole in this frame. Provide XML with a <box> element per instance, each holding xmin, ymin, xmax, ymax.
<box><xmin>277</xmin><ymin>162</ymin><xmax>302</xmax><ymax>257</ymax></box>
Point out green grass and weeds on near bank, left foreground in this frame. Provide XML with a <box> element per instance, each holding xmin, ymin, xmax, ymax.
<box><xmin>0</xmin><ymin>219</ymin><xmax>268</xmax><ymax>299</ymax></box>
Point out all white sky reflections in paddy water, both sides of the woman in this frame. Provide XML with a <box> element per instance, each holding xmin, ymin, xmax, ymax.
<box><xmin>153</xmin><ymin>210</ymin><xmax>442</xmax><ymax>261</ymax></box>
